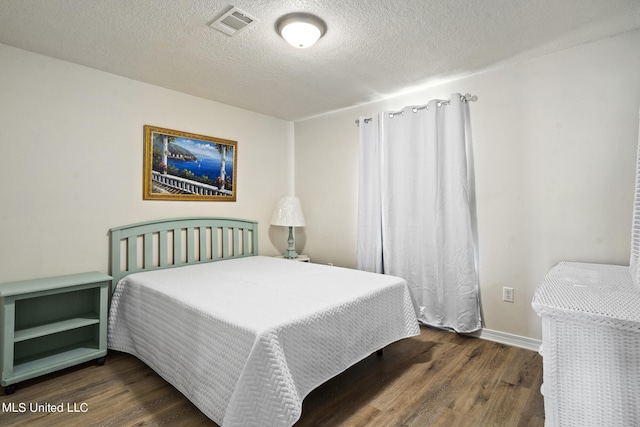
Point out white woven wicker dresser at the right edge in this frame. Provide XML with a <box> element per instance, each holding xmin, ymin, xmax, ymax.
<box><xmin>532</xmin><ymin>262</ymin><xmax>640</xmax><ymax>427</ymax></box>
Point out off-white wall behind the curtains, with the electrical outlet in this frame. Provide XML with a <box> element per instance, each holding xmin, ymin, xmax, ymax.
<box><xmin>295</xmin><ymin>31</ymin><xmax>640</xmax><ymax>339</ymax></box>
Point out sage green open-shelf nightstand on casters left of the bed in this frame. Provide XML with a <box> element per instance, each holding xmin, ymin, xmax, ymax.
<box><xmin>0</xmin><ymin>272</ymin><xmax>111</xmax><ymax>394</ymax></box>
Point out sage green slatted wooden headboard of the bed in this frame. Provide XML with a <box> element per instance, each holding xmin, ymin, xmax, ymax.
<box><xmin>109</xmin><ymin>217</ymin><xmax>258</xmax><ymax>291</ymax></box>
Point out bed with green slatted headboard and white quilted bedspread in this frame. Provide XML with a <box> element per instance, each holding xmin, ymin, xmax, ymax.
<box><xmin>108</xmin><ymin>218</ymin><xmax>419</xmax><ymax>427</ymax></box>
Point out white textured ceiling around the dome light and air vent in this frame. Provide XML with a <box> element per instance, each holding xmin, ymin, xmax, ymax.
<box><xmin>0</xmin><ymin>0</ymin><xmax>640</xmax><ymax>120</ymax></box>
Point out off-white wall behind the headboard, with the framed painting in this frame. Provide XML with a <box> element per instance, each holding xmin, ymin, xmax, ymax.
<box><xmin>0</xmin><ymin>44</ymin><xmax>293</xmax><ymax>282</ymax></box>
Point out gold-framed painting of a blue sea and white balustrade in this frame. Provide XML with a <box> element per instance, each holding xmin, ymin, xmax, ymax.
<box><xmin>143</xmin><ymin>125</ymin><xmax>238</xmax><ymax>202</ymax></box>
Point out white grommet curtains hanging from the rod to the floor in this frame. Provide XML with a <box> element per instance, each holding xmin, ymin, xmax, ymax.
<box><xmin>357</xmin><ymin>94</ymin><xmax>481</xmax><ymax>332</ymax></box>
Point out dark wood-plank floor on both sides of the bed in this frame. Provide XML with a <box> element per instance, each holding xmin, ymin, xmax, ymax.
<box><xmin>0</xmin><ymin>327</ymin><xmax>544</xmax><ymax>427</ymax></box>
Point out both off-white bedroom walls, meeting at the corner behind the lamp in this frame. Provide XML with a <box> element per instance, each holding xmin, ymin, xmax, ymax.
<box><xmin>0</xmin><ymin>31</ymin><xmax>640</xmax><ymax>338</ymax></box>
